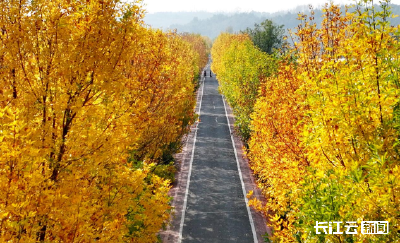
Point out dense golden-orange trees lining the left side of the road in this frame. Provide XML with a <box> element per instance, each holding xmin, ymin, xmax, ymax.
<box><xmin>0</xmin><ymin>0</ymin><xmax>206</xmax><ymax>242</ymax></box>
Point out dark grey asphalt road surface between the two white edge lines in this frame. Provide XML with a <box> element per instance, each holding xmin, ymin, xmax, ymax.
<box><xmin>182</xmin><ymin>69</ymin><xmax>255</xmax><ymax>243</ymax></box>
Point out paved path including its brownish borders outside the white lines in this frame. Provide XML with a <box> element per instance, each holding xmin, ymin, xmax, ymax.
<box><xmin>160</xmin><ymin>65</ymin><xmax>271</xmax><ymax>243</ymax></box>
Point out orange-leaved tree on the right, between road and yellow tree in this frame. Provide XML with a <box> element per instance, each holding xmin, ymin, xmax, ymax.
<box><xmin>248</xmin><ymin>60</ymin><xmax>309</xmax><ymax>238</ymax></box>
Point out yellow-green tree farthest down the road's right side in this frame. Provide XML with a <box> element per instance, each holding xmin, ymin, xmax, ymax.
<box><xmin>211</xmin><ymin>33</ymin><xmax>275</xmax><ymax>141</ymax></box>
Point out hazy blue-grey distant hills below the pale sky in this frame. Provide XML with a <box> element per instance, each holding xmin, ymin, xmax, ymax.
<box><xmin>145</xmin><ymin>4</ymin><xmax>400</xmax><ymax>39</ymax></box>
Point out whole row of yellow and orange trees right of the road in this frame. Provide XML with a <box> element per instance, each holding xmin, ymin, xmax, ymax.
<box><xmin>212</xmin><ymin>1</ymin><xmax>400</xmax><ymax>242</ymax></box>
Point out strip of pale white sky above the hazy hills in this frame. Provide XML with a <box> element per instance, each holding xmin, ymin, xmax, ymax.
<box><xmin>144</xmin><ymin>0</ymin><xmax>400</xmax><ymax>13</ymax></box>
